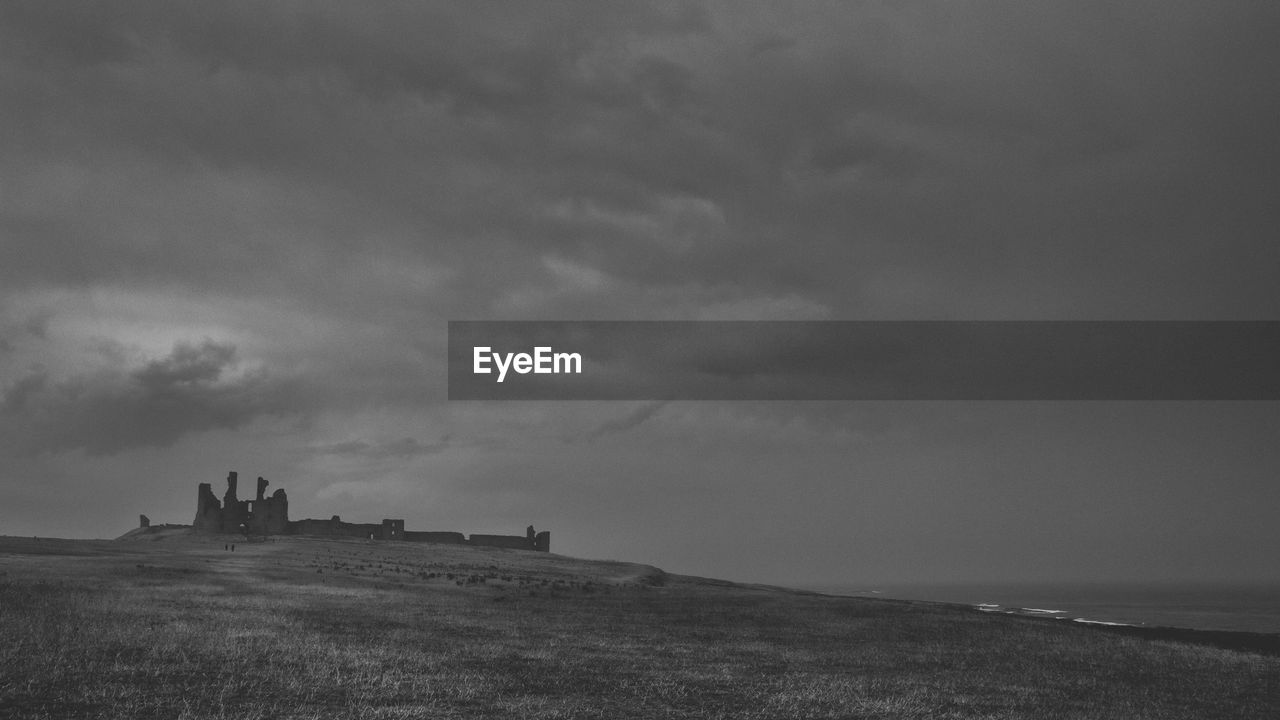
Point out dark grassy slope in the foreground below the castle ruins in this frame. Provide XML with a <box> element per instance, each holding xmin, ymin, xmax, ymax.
<box><xmin>0</xmin><ymin>537</ymin><xmax>1280</xmax><ymax>719</ymax></box>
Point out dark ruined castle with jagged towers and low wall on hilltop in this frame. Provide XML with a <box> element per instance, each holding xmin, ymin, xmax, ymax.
<box><xmin>192</xmin><ymin>471</ymin><xmax>552</xmax><ymax>552</ymax></box>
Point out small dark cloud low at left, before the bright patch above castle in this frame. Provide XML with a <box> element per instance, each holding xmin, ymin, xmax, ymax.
<box><xmin>0</xmin><ymin>341</ymin><xmax>311</xmax><ymax>455</ymax></box>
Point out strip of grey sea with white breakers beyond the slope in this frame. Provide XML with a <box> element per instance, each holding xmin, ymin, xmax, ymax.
<box><xmin>806</xmin><ymin>583</ymin><xmax>1280</xmax><ymax>633</ymax></box>
